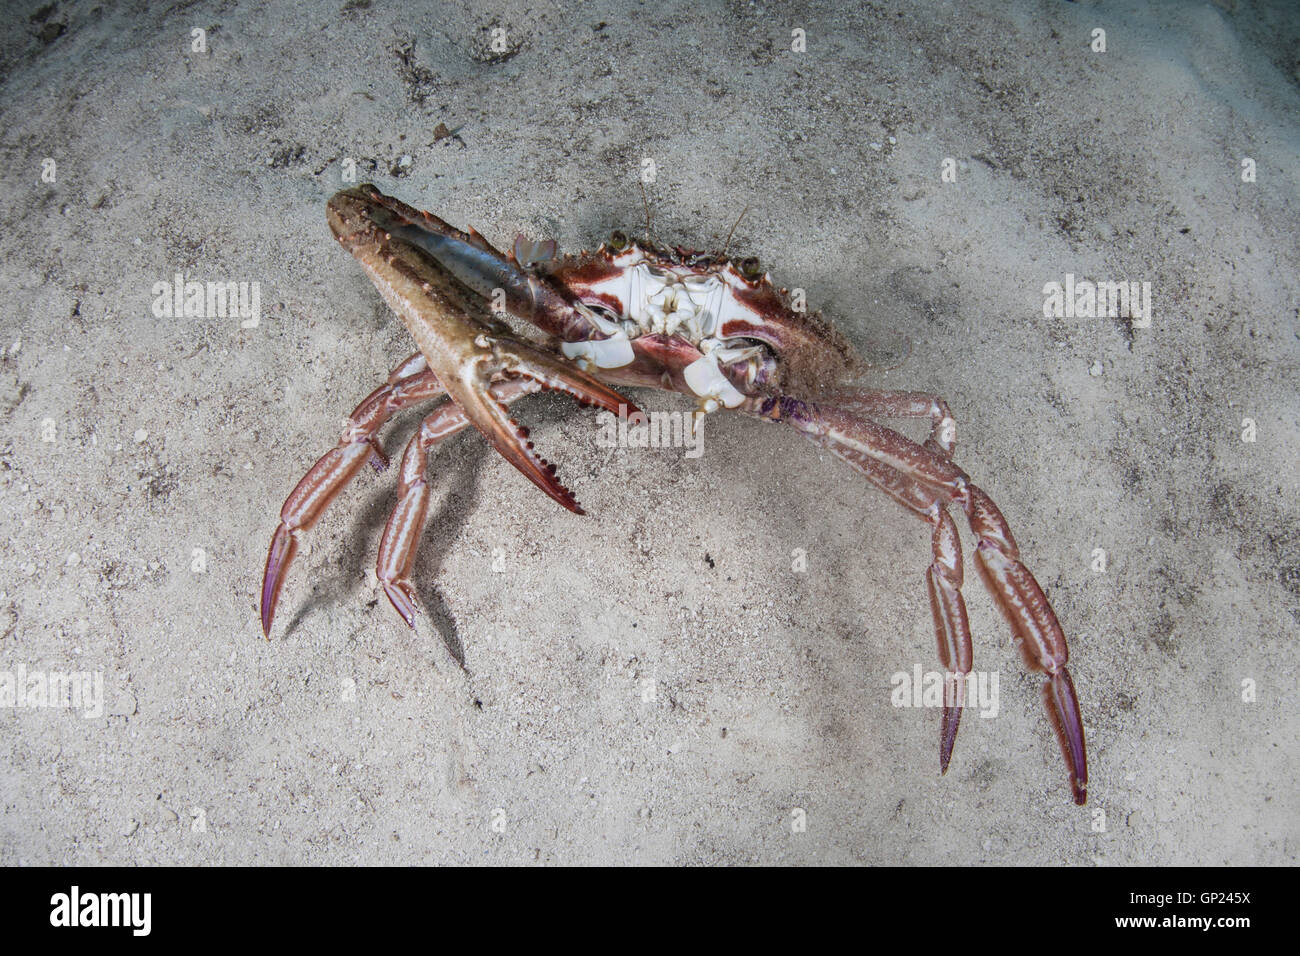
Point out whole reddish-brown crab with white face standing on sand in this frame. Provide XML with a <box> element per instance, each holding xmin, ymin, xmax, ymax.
<box><xmin>261</xmin><ymin>185</ymin><xmax>1088</xmax><ymax>805</ymax></box>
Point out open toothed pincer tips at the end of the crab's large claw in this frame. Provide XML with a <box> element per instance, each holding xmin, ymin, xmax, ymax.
<box><xmin>443</xmin><ymin>336</ymin><xmax>640</xmax><ymax>515</ymax></box>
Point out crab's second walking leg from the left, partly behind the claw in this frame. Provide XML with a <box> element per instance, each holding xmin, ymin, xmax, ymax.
<box><xmin>376</xmin><ymin>378</ymin><xmax>543</xmax><ymax>627</ymax></box>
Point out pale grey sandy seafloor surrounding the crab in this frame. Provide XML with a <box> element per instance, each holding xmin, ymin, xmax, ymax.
<box><xmin>0</xmin><ymin>0</ymin><xmax>1300</xmax><ymax>865</ymax></box>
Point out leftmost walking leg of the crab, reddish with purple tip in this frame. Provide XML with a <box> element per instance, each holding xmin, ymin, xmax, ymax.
<box><xmin>261</xmin><ymin>352</ymin><xmax>443</xmax><ymax>637</ymax></box>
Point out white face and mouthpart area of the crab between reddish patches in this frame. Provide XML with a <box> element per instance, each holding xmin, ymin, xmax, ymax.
<box><xmin>560</xmin><ymin>246</ymin><xmax>762</xmax><ymax>411</ymax></box>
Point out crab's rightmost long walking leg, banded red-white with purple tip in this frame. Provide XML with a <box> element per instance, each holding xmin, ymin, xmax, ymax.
<box><xmin>744</xmin><ymin>397</ymin><xmax>1088</xmax><ymax>805</ymax></box>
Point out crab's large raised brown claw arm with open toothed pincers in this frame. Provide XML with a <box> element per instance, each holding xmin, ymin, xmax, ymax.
<box><xmin>326</xmin><ymin>186</ymin><xmax>636</xmax><ymax>514</ymax></box>
